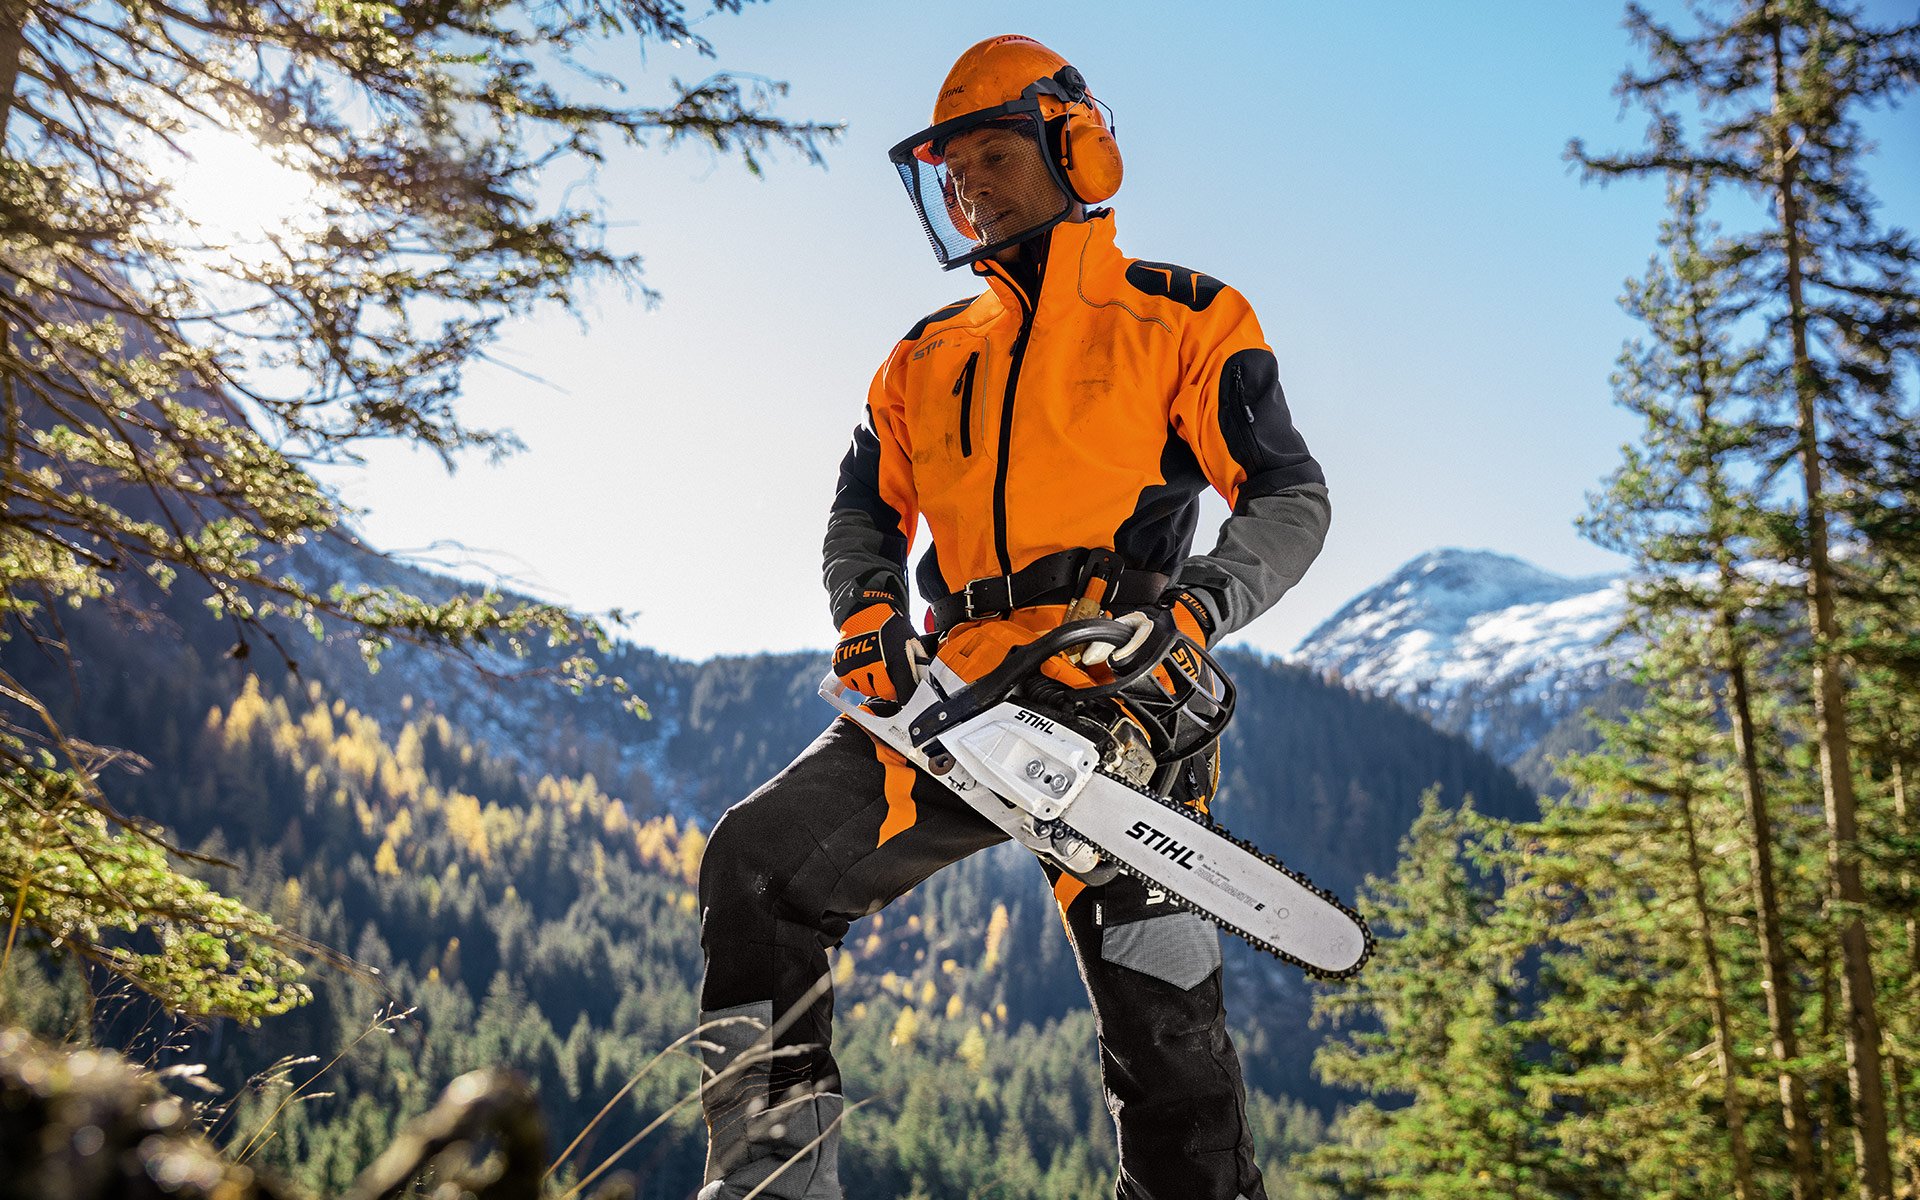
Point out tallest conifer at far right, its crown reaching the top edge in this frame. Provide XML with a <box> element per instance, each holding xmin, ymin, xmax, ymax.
<box><xmin>1572</xmin><ymin>0</ymin><xmax>1920</xmax><ymax>1200</ymax></box>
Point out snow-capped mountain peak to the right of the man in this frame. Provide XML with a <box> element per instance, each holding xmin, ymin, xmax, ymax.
<box><xmin>1288</xmin><ymin>549</ymin><xmax>1630</xmax><ymax>764</ymax></box>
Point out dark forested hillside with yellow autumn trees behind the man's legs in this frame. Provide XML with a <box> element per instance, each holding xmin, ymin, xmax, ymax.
<box><xmin>4</xmin><ymin>556</ymin><xmax>1528</xmax><ymax>1196</ymax></box>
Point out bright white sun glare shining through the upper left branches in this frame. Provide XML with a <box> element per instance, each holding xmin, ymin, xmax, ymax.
<box><xmin>167</xmin><ymin>129</ymin><xmax>321</xmax><ymax>257</ymax></box>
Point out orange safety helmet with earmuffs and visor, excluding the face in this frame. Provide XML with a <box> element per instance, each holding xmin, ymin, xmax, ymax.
<box><xmin>889</xmin><ymin>35</ymin><xmax>1121</xmax><ymax>269</ymax></box>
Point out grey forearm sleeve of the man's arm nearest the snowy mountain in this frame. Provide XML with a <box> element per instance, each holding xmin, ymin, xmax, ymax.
<box><xmin>1173</xmin><ymin>484</ymin><xmax>1332</xmax><ymax>641</ymax></box>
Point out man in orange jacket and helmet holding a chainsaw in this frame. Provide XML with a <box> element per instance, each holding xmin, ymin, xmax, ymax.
<box><xmin>701</xmin><ymin>36</ymin><xmax>1329</xmax><ymax>1200</ymax></box>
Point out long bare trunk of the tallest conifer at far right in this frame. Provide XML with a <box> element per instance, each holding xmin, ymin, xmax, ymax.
<box><xmin>1770</xmin><ymin>21</ymin><xmax>1893</xmax><ymax>1200</ymax></box>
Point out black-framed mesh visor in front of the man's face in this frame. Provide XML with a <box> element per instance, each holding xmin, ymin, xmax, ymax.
<box><xmin>889</xmin><ymin>98</ymin><xmax>1073</xmax><ymax>271</ymax></box>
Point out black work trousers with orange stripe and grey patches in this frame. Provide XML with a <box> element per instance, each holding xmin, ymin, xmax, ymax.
<box><xmin>699</xmin><ymin>718</ymin><xmax>1265</xmax><ymax>1200</ymax></box>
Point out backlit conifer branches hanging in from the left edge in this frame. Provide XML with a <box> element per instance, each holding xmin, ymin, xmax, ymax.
<box><xmin>0</xmin><ymin>0</ymin><xmax>835</xmax><ymax>1018</ymax></box>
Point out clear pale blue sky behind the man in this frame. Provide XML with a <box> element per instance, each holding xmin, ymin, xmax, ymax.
<box><xmin>307</xmin><ymin>0</ymin><xmax>1920</xmax><ymax>657</ymax></box>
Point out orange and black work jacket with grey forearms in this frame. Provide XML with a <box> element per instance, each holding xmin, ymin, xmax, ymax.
<box><xmin>826</xmin><ymin>209</ymin><xmax>1329</xmax><ymax>639</ymax></box>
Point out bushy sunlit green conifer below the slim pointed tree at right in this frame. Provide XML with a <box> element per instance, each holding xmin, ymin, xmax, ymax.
<box><xmin>1528</xmin><ymin>656</ymin><xmax>1770</xmax><ymax>1200</ymax></box>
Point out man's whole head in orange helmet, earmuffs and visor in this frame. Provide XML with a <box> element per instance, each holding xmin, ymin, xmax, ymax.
<box><xmin>889</xmin><ymin>35</ymin><xmax>1121</xmax><ymax>271</ymax></box>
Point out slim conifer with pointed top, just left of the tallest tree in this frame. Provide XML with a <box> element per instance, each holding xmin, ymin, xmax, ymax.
<box><xmin>1582</xmin><ymin>173</ymin><xmax>1818</xmax><ymax>1200</ymax></box>
